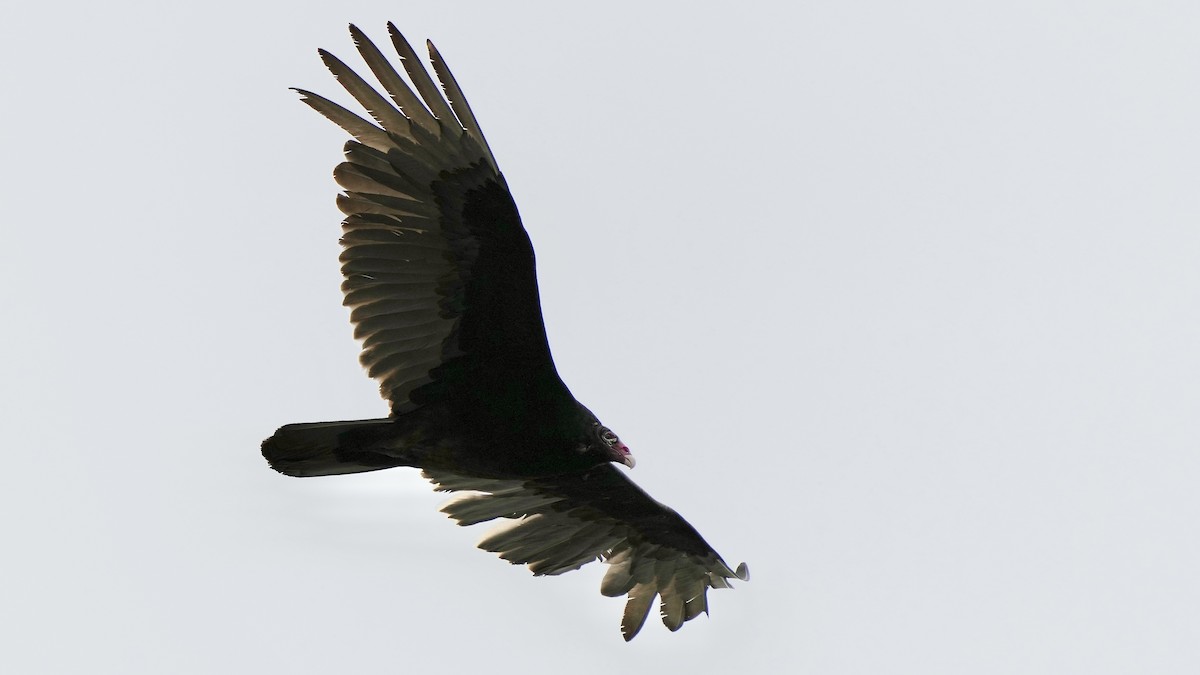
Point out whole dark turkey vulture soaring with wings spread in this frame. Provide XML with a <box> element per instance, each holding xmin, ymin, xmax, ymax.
<box><xmin>263</xmin><ymin>23</ymin><xmax>749</xmax><ymax>640</ymax></box>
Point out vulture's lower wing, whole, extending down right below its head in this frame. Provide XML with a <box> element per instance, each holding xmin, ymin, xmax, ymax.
<box><xmin>425</xmin><ymin>464</ymin><xmax>749</xmax><ymax>640</ymax></box>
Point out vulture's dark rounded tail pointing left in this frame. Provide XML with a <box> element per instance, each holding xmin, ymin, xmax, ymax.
<box><xmin>263</xmin><ymin>419</ymin><xmax>404</xmax><ymax>477</ymax></box>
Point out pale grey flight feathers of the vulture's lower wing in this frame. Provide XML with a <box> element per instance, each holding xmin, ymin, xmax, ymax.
<box><xmin>424</xmin><ymin>466</ymin><xmax>749</xmax><ymax>640</ymax></box>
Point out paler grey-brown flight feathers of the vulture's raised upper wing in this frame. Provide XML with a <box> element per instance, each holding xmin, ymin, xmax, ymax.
<box><xmin>298</xmin><ymin>23</ymin><xmax>503</xmax><ymax>413</ymax></box>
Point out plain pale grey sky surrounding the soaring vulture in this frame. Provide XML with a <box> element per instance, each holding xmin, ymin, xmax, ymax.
<box><xmin>0</xmin><ymin>0</ymin><xmax>1200</xmax><ymax>675</ymax></box>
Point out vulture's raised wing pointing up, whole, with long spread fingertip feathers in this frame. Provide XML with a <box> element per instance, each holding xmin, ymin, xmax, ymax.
<box><xmin>298</xmin><ymin>23</ymin><xmax>574</xmax><ymax>414</ymax></box>
